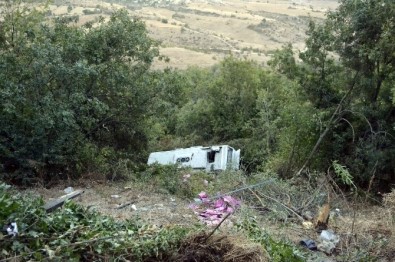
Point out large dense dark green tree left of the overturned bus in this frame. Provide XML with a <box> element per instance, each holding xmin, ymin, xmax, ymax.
<box><xmin>0</xmin><ymin>5</ymin><xmax>158</xmax><ymax>182</ymax></box>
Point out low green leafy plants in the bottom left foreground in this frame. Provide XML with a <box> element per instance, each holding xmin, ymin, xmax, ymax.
<box><xmin>0</xmin><ymin>184</ymin><xmax>188</xmax><ymax>261</ymax></box>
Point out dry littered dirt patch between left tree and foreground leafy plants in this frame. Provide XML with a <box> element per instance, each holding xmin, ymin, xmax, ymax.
<box><xmin>25</xmin><ymin>180</ymin><xmax>198</xmax><ymax>226</ymax></box>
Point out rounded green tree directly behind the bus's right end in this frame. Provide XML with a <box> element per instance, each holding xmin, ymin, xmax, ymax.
<box><xmin>208</xmin><ymin>57</ymin><xmax>261</xmax><ymax>141</ymax></box>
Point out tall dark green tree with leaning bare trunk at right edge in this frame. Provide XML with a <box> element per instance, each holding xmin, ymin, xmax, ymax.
<box><xmin>299</xmin><ymin>0</ymin><xmax>395</xmax><ymax>188</ymax></box>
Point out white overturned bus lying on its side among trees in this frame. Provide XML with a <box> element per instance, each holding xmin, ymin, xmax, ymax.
<box><xmin>148</xmin><ymin>145</ymin><xmax>240</xmax><ymax>172</ymax></box>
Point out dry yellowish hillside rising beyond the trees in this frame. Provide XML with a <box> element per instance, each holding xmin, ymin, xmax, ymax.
<box><xmin>51</xmin><ymin>0</ymin><xmax>338</xmax><ymax>69</ymax></box>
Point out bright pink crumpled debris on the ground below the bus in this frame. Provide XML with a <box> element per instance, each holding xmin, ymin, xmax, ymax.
<box><xmin>189</xmin><ymin>192</ymin><xmax>240</xmax><ymax>225</ymax></box>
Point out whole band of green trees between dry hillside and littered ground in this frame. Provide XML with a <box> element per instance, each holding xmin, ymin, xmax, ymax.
<box><xmin>0</xmin><ymin>0</ymin><xmax>395</xmax><ymax>189</ymax></box>
